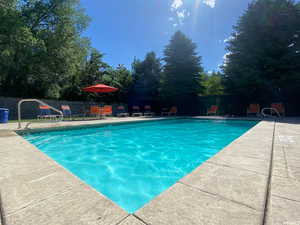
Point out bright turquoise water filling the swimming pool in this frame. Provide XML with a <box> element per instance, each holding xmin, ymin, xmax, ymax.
<box><xmin>24</xmin><ymin>119</ymin><xmax>256</xmax><ymax>213</ymax></box>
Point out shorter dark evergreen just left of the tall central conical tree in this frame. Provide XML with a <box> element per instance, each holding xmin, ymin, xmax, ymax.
<box><xmin>132</xmin><ymin>52</ymin><xmax>162</xmax><ymax>102</ymax></box>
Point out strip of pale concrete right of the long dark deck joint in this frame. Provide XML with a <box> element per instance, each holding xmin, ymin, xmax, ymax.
<box><xmin>266</xmin><ymin>120</ymin><xmax>300</xmax><ymax>225</ymax></box>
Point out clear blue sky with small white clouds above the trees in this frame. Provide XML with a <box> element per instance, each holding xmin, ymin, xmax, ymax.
<box><xmin>81</xmin><ymin>0</ymin><xmax>251</xmax><ymax>71</ymax></box>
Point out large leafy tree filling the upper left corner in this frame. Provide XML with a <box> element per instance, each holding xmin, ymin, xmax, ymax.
<box><xmin>0</xmin><ymin>0</ymin><xmax>89</xmax><ymax>98</ymax></box>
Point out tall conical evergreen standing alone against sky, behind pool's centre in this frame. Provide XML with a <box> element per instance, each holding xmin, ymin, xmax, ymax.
<box><xmin>161</xmin><ymin>31</ymin><xmax>203</xmax><ymax>110</ymax></box>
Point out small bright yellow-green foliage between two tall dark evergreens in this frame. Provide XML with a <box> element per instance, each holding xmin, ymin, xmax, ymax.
<box><xmin>200</xmin><ymin>72</ymin><xmax>224</xmax><ymax>96</ymax></box>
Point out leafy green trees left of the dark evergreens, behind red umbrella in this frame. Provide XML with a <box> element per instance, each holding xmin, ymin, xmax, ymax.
<box><xmin>0</xmin><ymin>0</ymin><xmax>132</xmax><ymax>101</ymax></box>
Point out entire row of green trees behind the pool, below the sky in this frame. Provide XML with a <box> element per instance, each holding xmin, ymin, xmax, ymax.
<box><xmin>0</xmin><ymin>0</ymin><xmax>300</xmax><ymax>113</ymax></box>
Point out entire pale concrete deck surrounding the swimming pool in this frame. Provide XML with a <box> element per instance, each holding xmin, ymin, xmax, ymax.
<box><xmin>0</xmin><ymin>117</ymin><xmax>300</xmax><ymax>225</ymax></box>
